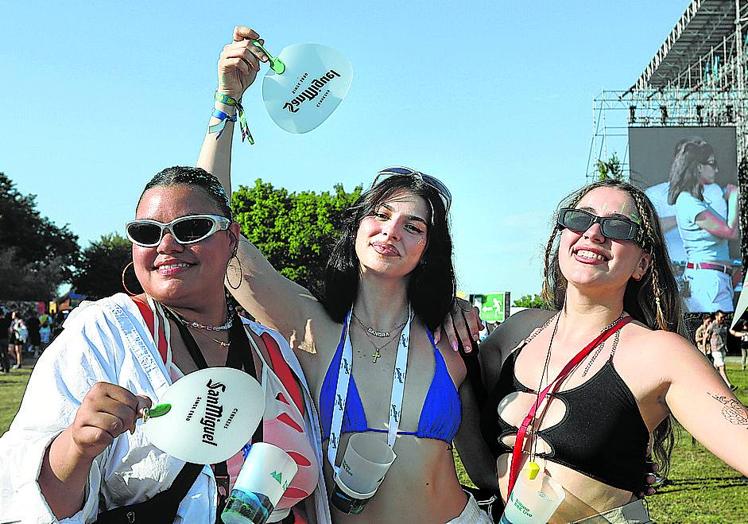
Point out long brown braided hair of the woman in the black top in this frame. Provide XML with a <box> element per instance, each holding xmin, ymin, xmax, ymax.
<box><xmin>543</xmin><ymin>179</ymin><xmax>689</xmax><ymax>477</ymax></box>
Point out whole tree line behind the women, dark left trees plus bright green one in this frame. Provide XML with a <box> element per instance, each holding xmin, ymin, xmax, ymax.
<box><xmin>0</xmin><ymin>172</ymin><xmax>362</xmax><ymax>301</ymax></box>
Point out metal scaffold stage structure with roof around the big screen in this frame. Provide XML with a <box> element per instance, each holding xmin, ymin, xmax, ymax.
<box><xmin>587</xmin><ymin>0</ymin><xmax>748</xmax><ymax>267</ymax></box>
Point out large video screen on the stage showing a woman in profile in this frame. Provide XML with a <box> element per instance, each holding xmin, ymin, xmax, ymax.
<box><xmin>629</xmin><ymin>127</ymin><xmax>742</xmax><ymax>313</ymax></box>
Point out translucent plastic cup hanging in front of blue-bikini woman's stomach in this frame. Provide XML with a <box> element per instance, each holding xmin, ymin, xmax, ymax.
<box><xmin>330</xmin><ymin>433</ymin><xmax>397</xmax><ymax>515</ymax></box>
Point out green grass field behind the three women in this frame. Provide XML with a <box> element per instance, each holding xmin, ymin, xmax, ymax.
<box><xmin>0</xmin><ymin>365</ymin><xmax>748</xmax><ymax>524</ymax></box>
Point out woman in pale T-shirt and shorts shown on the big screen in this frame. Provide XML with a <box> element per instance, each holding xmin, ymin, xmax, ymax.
<box><xmin>668</xmin><ymin>137</ymin><xmax>740</xmax><ymax>312</ymax></box>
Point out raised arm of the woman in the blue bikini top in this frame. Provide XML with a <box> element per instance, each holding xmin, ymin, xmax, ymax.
<box><xmin>197</xmin><ymin>26</ymin><xmax>326</xmax><ymax>342</ymax></box>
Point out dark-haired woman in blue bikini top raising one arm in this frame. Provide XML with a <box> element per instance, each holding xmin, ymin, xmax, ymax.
<box><xmin>199</xmin><ymin>28</ymin><xmax>488</xmax><ymax>523</ymax></box>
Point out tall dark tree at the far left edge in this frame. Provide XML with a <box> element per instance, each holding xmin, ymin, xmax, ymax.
<box><xmin>0</xmin><ymin>173</ymin><xmax>78</xmax><ymax>300</ymax></box>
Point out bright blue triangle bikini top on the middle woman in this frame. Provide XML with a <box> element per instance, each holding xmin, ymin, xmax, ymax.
<box><xmin>319</xmin><ymin>314</ymin><xmax>462</xmax><ymax>443</ymax></box>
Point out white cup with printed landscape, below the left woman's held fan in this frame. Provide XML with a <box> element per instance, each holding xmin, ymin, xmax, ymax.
<box><xmin>221</xmin><ymin>442</ymin><xmax>298</xmax><ymax>524</ymax></box>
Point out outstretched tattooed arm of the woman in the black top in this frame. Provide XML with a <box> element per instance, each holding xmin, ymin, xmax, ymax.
<box><xmin>655</xmin><ymin>332</ymin><xmax>748</xmax><ymax>475</ymax></box>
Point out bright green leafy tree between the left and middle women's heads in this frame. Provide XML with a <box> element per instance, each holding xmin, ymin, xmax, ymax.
<box><xmin>232</xmin><ymin>179</ymin><xmax>361</xmax><ymax>293</ymax></box>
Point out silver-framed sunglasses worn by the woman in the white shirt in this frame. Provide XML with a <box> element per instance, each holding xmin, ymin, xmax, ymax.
<box><xmin>125</xmin><ymin>215</ymin><xmax>231</xmax><ymax>247</ymax></box>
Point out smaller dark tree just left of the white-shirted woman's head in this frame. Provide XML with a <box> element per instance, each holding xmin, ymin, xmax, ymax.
<box><xmin>72</xmin><ymin>233</ymin><xmax>136</xmax><ymax>298</ymax></box>
